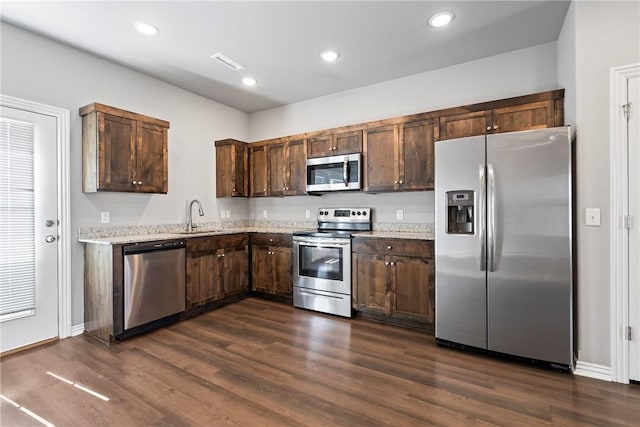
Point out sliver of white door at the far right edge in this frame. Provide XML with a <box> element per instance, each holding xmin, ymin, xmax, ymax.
<box><xmin>627</xmin><ymin>76</ymin><xmax>640</xmax><ymax>381</ymax></box>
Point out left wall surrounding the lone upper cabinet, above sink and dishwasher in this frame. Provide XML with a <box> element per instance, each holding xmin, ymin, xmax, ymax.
<box><xmin>0</xmin><ymin>22</ymin><xmax>248</xmax><ymax>325</ymax></box>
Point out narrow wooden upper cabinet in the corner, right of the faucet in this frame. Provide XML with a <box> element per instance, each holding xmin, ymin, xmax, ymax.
<box><xmin>215</xmin><ymin>139</ymin><xmax>249</xmax><ymax>197</ymax></box>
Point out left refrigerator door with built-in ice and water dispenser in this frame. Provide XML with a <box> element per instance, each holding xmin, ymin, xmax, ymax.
<box><xmin>435</xmin><ymin>136</ymin><xmax>487</xmax><ymax>348</ymax></box>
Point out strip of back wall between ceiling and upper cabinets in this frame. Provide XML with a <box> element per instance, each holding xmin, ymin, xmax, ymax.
<box><xmin>249</xmin><ymin>42</ymin><xmax>559</xmax><ymax>141</ymax></box>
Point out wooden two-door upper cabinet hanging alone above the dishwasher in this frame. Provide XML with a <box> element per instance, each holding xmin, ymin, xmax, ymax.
<box><xmin>80</xmin><ymin>103</ymin><xmax>169</xmax><ymax>194</ymax></box>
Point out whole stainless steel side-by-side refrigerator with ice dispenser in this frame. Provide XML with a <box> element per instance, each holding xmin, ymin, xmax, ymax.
<box><xmin>435</xmin><ymin>127</ymin><xmax>574</xmax><ymax>368</ymax></box>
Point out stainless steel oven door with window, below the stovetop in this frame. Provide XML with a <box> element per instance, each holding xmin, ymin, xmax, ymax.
<box><xmin>293</xmin><ymin>236</ymin><xmax>351</xmax><ymax>295</ymax></box>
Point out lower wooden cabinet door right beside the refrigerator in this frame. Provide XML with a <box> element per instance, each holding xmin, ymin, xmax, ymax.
<box><xmin>391</xmin><ymin>257</ymin><xmax>435</xmax><ymax>324</ymax></box>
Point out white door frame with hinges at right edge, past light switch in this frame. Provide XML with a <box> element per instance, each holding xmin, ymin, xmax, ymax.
<box><xmin>609</xmin><ymin>64</ymin><xmax>640</xmax><ymax>384</ymax></box>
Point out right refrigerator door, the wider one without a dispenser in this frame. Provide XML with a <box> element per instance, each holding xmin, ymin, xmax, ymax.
<box><xmin>487</xmin><ymin>127</ymin><xmax>573</xmax><ymax>365</ymax></box>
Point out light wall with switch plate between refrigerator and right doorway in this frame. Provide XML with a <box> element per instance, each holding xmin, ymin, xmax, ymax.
<box><xmin>558</xmin><ymin>1</ymin><xmax>640</xmax><ymax>366</ymax></box>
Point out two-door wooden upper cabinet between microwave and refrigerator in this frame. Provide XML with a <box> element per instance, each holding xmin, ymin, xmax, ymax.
<box><xmin>363</xmin><ymin>118</ymin><xmax>439</xmax><ymax>192</ymax></box>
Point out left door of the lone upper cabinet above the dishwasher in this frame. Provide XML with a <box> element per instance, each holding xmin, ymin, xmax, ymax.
<box><xmin>97</xmin><ymin>112</ymin><xmax>136</xmax><ymax>191</ymax></box>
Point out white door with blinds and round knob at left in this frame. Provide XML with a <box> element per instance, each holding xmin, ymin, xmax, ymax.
<box><xmin>0</xmin><ymin>107</ymin><xmax>58</xmax><ymax>353</ymax></box>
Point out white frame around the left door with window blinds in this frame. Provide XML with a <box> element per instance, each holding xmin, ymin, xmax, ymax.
<box><xmin>0</xmin><ymin>94</ymin><xmax>71</xmax><ymax>339</ymax></box>
